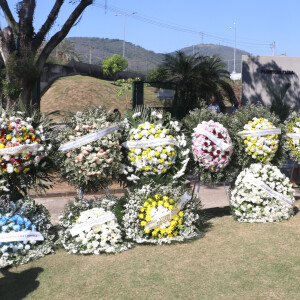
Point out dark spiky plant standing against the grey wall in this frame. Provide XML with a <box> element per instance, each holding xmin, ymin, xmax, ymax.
<box><xmin>267</xmin><ymin>82</ymin><xmax>291</xmax><ymax>122</ymax></box>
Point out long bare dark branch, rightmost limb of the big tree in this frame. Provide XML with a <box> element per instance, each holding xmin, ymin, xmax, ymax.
<box><xmin>36</xmin><ymin>0</ymin><xmax>93</xmax><ymax>71</ymax></box>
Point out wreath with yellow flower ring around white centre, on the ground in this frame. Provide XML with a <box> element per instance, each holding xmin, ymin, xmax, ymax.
<box><xmin>123</xmin><ymin>184</ymin><xmax>202</xmax><ymax>244</ymax></box>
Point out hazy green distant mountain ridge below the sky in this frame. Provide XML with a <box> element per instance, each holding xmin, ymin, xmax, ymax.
<box><xmin>67</xmin><ymin>37</ymin><xmax>249</xmax><ymax>73</ymax></box>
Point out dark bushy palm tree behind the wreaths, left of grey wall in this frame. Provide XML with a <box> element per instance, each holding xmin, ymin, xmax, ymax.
<box><xmin>162</xmin><ymin>51</ymin><xmax>236</xmax><ymax>117</ymax></box>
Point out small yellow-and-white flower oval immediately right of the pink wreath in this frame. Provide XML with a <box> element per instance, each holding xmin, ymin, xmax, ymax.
<box><xmin>241</xmin><ymin>118</ymin><xmax>279</xmax><ymax>163</ymax></box>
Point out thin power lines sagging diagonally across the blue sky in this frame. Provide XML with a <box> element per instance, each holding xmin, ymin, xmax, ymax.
<box><xmin>94</xmin><ymin>3</ymin><xmax>271</xmax><ymax>48</ymax></box>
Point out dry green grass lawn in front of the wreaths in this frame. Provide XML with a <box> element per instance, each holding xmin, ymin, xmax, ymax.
<box><xmin>0</xmin><ymin>200</ymin><xmax>300</xmax><ymax>300</ymax></box>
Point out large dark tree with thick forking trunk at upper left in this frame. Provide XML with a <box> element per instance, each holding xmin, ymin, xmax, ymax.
<box><xmin>0</xmin><ymin>0</ymin><xmax>93</xmax><ymax>106</ymax></box>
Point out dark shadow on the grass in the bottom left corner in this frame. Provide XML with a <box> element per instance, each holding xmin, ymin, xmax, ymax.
<box><xmin>0</xmin><ymin>268</ymin><xmax>44</xmax><ymax>300</ymax></box>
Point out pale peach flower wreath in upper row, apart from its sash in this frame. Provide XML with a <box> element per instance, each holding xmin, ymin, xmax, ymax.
<box><xmin>57</xmin><ymin>106</ymin><xmax>122</xmax><ymax>192</ymax></box>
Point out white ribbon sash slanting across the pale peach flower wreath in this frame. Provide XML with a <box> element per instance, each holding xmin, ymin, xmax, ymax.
<box><xmin>58</xmin><ymin>126</ymin><xmax>119</xmax><ymax>151</ymax></box>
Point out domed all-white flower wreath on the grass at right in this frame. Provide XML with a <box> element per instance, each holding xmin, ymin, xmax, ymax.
<box><xmin>230</xmin><ymin>163</ymin><xmax>295</xmax><ymax>223</ymax></box>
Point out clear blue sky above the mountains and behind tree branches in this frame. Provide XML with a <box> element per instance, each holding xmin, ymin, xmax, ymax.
<box><xmin>0</xmin><ymin>0</ymin><xmax>300</xmax><ymax>56</ymax></box>
